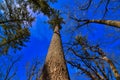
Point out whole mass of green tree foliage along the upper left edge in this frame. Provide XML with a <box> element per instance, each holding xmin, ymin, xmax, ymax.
<box><xmin>0</xmin><ymin>0</ymin><xmax>34</xmax><ymax>54</ymax></box>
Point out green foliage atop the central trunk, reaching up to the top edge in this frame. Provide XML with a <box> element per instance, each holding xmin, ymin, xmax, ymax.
<box><xmin>28</xmin><ymin>0</ymin><xmax>64</xmax><ymax>29</ymax></box>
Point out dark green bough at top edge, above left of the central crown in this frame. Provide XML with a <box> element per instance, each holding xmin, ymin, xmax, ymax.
<box><xmin>28</xmin><ymin>0</ymin><xmax>57</xmax><ymax>17</ymax></box>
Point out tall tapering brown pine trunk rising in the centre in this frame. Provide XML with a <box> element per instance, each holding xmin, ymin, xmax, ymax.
<box><xmin>40</xmin><ymin>26</ymin><xmax>70</xmax><ymax>80</ymax></box>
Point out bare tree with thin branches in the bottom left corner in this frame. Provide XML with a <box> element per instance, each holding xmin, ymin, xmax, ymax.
<box><xmin>0</xmin><ymin>55</ymin><xmax>21</xmax><ymax>80</ymax></box>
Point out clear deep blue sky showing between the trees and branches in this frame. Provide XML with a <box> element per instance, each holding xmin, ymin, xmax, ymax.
<box><xmin>0</xmin><ymin>0</ymin><xmax>120</xmax><ymax>80</ymax></box>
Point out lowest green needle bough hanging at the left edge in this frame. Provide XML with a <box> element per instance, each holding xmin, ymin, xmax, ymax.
<box><xmin>0</xmin><ymin>28</ymin><xmax>30</xmax><ymax>54</ymax></box>
